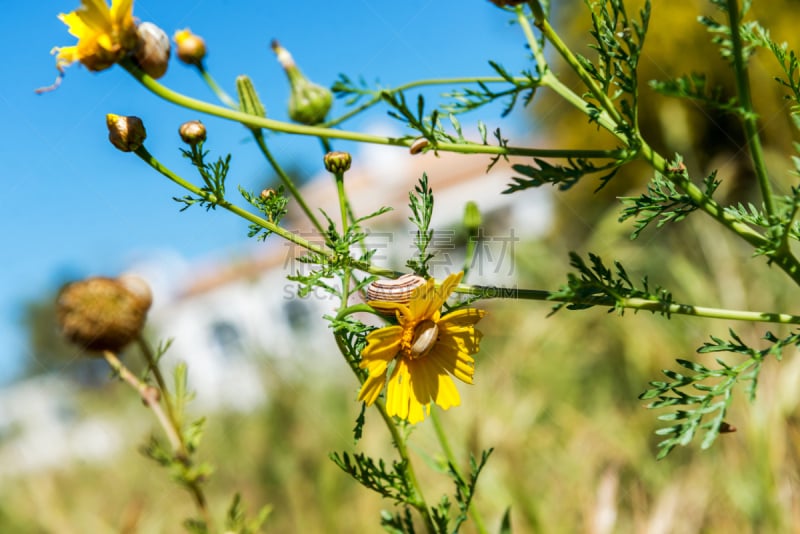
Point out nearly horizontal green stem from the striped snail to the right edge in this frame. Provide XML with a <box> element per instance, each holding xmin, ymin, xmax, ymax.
<box><xmin>455</xmin><ymin>284</ymin><xmax>800</xmax><ymax>324</ymax></box>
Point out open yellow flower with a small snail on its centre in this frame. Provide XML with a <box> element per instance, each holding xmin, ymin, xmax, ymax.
<box><xmin>358</xmin><ymin>273</ymin><xmax>486</xmax><ymax>423</ymax></box>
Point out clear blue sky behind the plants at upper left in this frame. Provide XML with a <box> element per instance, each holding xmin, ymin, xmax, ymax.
<box><xmin>0</xmin><ymin>0</ymin><xmax>531</xmax><ymax>383</ymax></box>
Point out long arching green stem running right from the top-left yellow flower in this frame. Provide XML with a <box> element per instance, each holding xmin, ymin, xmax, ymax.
<box><xmin>120</xmin><ymin>60</ymin><xmax>627</xmax><ymax>159</ymax></box>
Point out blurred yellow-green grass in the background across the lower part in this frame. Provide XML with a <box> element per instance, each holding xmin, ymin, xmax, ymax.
<box><xmin>0</xmin><ymin>205</ymin><xmax>800</xmax><ymax>533</ymax></box>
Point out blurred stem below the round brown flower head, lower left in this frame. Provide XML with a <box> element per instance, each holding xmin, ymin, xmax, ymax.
<box><xmin>103</xmin><ymin>352</ymin><xmax>214</xmax><ymax>532</ymax></box>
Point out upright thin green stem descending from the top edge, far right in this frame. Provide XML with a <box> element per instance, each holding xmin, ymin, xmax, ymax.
<box><xmin>728</xmin><ymin>0</ymin><xmax>775</xmax><ymax>217</ymax></box>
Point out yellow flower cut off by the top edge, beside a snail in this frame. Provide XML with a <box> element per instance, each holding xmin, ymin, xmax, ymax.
<box><xmin>53</xmin><ymin>0</ymin><xmax>137</xmax><ymax>71</ymax></box>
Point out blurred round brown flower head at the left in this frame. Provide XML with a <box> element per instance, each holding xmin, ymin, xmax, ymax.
<box><xmin>56</xmin><ymin>277</ymin><xmax>151</xmax><ymax>352</ymax></box>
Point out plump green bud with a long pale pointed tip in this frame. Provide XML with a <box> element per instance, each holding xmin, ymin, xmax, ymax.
<box><xmin>272</xmin><ymin>41</ymin><xmax>333</xmax><ymax>126</ymax></box>
